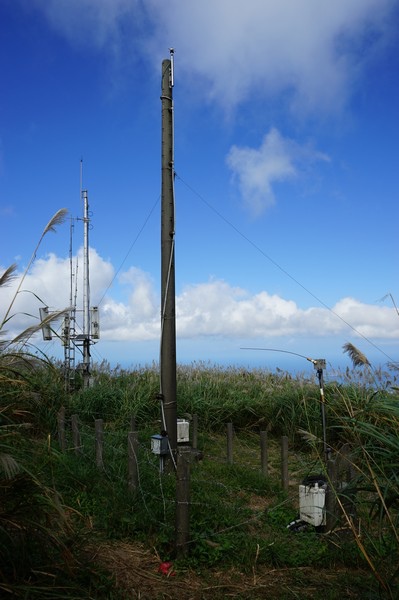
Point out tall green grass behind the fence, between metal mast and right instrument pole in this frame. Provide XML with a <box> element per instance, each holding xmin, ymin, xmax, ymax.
<box><xmin>80</xmin><ymin>363</ymin><xmax>320</xmax><ymax>438</ymax></box>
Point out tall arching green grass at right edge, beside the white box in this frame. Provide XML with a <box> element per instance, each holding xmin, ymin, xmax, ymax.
<box><xmin>333</xmin><ymin>378</ymin><xmax>399</xmax><ymax>591</ymax></box>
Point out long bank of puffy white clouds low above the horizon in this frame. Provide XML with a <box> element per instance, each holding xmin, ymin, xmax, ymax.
<box><xmin>0</xmin><ymin>249</ymin><xmax>399</xmax><ymax>350</ymax></box>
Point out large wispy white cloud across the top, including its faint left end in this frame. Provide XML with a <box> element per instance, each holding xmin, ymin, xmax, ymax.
<box><xmin>25</xmin><ymin>0</ymin><xmax>397</xmax><ymax>112</ymax></box>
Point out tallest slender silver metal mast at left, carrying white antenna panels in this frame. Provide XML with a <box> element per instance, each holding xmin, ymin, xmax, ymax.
<box><xmin>82</xmin><ymin>190</ymin><xmax>90</xmax><ymax>388</ymax></box>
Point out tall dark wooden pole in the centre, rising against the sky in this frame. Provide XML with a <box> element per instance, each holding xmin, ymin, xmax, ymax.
<box><xmin>160</xmin><ymin>50</ymin><xmax>177</xmax><ymax>457</ymax></box>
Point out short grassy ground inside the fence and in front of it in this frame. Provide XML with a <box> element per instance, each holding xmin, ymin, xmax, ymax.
<box><xmin>45</xmin><ymin>432</ymin><xmax>378</xmax><ymax>599</ymax></box>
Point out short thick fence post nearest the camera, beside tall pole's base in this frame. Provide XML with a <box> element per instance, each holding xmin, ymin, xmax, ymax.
<box><xmin>176</xmin><ymin>446</ymin><xmax>191</xmax><ymax>556</ymax></box>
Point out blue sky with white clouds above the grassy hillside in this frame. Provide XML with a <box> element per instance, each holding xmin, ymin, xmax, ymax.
<box><xmin>0</xmin><ymin>0</ymin><xmax>399</xmax><ymax>376</ymax></box>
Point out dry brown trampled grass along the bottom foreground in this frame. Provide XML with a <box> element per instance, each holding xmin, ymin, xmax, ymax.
<box><xmin>87</xmin><ymin>542</ymin><xmax>374</xmax><ymax>600</ymax></box>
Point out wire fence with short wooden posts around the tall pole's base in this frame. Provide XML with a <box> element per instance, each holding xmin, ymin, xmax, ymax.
<box><xmin>54</xmin><ymin>409</ymin><xmax>352</xmax><ymax>553</ymax></box>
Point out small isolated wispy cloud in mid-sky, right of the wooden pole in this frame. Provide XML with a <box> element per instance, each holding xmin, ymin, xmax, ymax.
<box><xmin>227</xmin><ymin>128</ymin><xmax>329</xmax><ymax>216</ymax></box>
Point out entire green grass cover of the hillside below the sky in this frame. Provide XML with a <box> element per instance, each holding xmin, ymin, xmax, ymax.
<box><xmin>0</xmin><ymin>353</ymin><xmax>399</xmax><ymax>599</ymax></box>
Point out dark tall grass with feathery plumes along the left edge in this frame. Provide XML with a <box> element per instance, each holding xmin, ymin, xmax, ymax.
<box><xmin>0</xmin><ymin>209</ymin><xmax>120</xmax><ymax>599</ymax></box>
